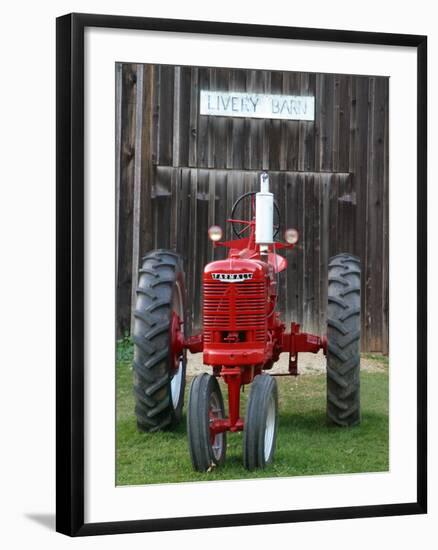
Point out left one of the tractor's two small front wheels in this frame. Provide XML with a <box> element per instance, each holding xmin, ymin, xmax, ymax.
<box><xmin>187</xmin><ymin>373</ymin><xmax>227</xmax><ymax>472</ymax></box>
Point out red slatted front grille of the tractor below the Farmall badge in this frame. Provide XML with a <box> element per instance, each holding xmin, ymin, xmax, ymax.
<box><xmin>203</xmin><ymin>281</ymin><xmax>266</xmax><ymax>343</ymax></box>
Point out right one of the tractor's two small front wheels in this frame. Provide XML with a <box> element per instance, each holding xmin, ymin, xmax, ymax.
<box><xmin>243</xmin><ymin>374</ymin><xmax>278</xmax><ymax>470</ymax></box>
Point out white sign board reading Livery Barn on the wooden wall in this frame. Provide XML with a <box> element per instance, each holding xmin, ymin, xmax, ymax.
<box><xmin>200</xmin><ymin>90</ymin><xmax>315</xmax><ymax>120</ymax></box>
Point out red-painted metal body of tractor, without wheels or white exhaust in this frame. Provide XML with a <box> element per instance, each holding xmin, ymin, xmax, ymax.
<box><xmin>181</xmin><ymin>211</ymin><xmax>327</xmax><ymax>441</ymax></box>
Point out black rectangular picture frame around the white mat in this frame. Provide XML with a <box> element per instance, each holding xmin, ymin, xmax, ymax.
<box><xmin>56</xmin><ymin>13</ymin><xmax>427</xmax><ymax>536</ymax></box>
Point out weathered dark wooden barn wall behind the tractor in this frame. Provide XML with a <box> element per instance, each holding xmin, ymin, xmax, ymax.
<box><xmin>116</xmin><ymin>64</ymin><xmax>389</xmax><ymax>353</ymax></box>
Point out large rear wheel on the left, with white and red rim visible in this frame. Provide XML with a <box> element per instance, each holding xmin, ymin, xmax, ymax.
<box><xmin>132</xmin><ymin>250</ymin><xmax>186</xmax><ymax>432</ymax></box>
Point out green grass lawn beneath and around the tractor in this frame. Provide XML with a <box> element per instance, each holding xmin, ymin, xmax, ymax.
<box><xmin>116</xmin><ymin>341</ymin><xmax>388</xmax><ymax>485</ymax></box>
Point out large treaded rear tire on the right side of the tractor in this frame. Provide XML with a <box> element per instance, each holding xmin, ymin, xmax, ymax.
<box><xmin>327</xmin><ymin>254</ymin><xmax>360</xmax><ymax>426</ymax></box>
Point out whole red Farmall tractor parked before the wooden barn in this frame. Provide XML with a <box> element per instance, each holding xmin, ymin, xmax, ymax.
<box><xmin>133</xmin><ymin>173</ymin><xmax>360</xmax><ymax>471</ymax></box>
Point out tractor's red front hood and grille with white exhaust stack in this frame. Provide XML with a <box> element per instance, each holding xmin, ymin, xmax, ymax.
<box><xmin>203</xmin><ymin>173</ymin><xmax>276</xmax><ymax>367</ymax></box>
